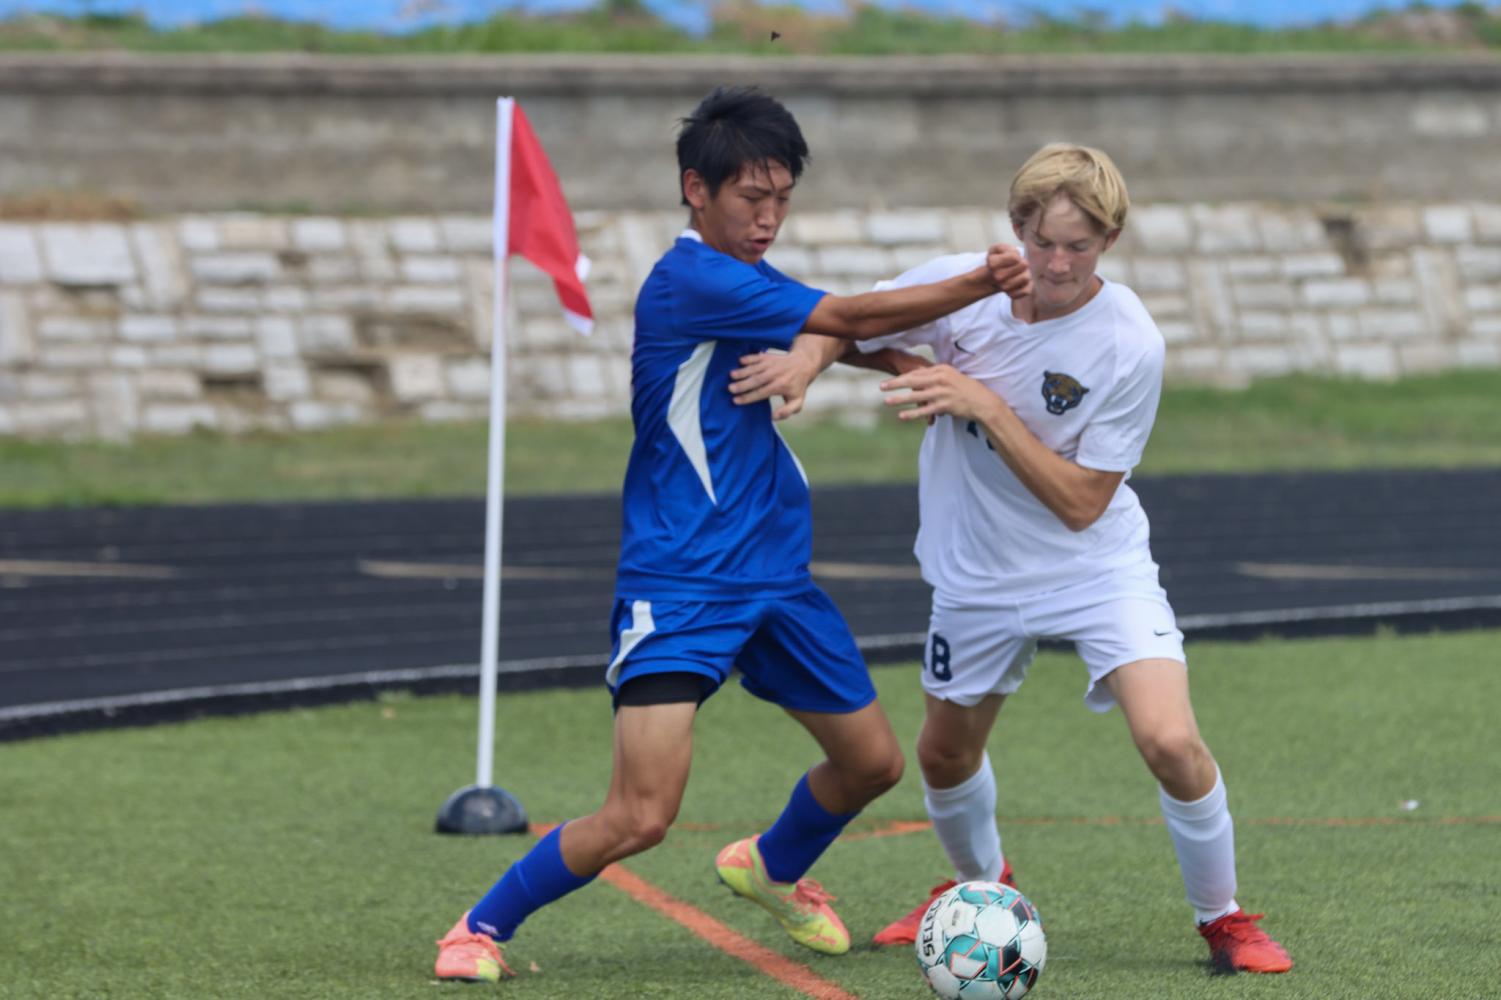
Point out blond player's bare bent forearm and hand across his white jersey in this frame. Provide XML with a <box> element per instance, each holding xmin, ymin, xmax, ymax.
<box><xmin>881</xmin><ymin>365</ymin><xmax>1126</xmax><ymax>532</ymax></box>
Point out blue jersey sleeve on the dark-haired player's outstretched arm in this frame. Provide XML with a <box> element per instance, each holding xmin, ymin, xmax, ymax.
<box><xmin>675</xmin><ymin>257</ymin><xmax>827</xmax><ymax>348</ymax></box>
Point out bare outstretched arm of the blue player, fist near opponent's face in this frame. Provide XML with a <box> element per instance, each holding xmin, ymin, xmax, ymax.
<box><xmin>806</xmin><ymin>243</ymin><xmax>1031</xmax><ymax>341</ymax></box>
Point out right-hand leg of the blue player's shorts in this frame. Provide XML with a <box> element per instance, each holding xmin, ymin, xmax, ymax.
<box><xmin>737</xmin><ymin>587</ymin><xmax>884</xmax><ymax>718</ymax></box>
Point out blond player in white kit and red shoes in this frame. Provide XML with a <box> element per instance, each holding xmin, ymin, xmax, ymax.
<box><xmin>731</xmin><ymin>144</ymin><xmax>1292</xmax><ymax>973</ymax></box>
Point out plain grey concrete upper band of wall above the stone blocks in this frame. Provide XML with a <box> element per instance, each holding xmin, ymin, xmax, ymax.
<box><xmin>0</xmin><ymin>54</ymin><xmax>1501</xmax><ymax>213</ymax></box>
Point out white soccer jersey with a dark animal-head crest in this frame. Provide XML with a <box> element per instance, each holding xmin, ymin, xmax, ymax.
<box><xmin>859</xmin><ymin>254</ymin><xmax>1163</xmax><ymax>607</ymax></box>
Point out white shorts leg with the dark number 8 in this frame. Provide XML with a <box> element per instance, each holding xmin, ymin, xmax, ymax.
<box><xmin>922</xmin><ymin>601</ymin><xmax>1037</xmax><ymax>705</ymax></box>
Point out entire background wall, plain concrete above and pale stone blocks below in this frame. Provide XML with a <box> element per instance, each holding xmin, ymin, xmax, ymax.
<box><xmin>0</xmin><ymin>54</ymin><xmax>1501</xmax><ymax>437</ymax></box>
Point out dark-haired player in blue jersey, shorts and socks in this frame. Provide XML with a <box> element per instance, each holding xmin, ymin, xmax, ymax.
<box><xmin>437</xmin><ymin>89</ymin><xmax>1031</xmax><ymax>980</ymax></box>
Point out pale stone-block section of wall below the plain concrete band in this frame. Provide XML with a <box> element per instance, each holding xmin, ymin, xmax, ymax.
<box><xmin>0</xmin><ymin>201</ymin><xmax>1501</xmax><ymax>438</ymax></box>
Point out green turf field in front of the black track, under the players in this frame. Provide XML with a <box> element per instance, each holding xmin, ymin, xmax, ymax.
<box><xmin>0</xmin><ymin>632</ymin><xmax>1501</xmax><ymax>1000</ymax></box>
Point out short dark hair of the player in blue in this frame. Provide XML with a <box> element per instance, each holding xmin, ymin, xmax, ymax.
<box><xmin>677</xmin><ymin>87</ymin><xmax>809</xmax><ymax>204</ymax></box>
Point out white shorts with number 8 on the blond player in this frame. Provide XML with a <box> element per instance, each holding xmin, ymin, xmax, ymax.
<box><xmin>923</xmin><ymin>563</ymin><xmax>1187</xmax><ymax>712</ymax></box>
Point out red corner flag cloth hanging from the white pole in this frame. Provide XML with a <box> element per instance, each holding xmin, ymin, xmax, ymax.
<box><xmin>507</xmin><ymin>104</ymin><xmax>594</xmax><ymax>335</ymax></box>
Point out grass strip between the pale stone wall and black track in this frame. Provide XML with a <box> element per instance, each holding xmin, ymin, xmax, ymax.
<box><xmin>0</xmin><ymin>369</ymin><xmax>1501</xmax><ymax>508</ymax></box>
